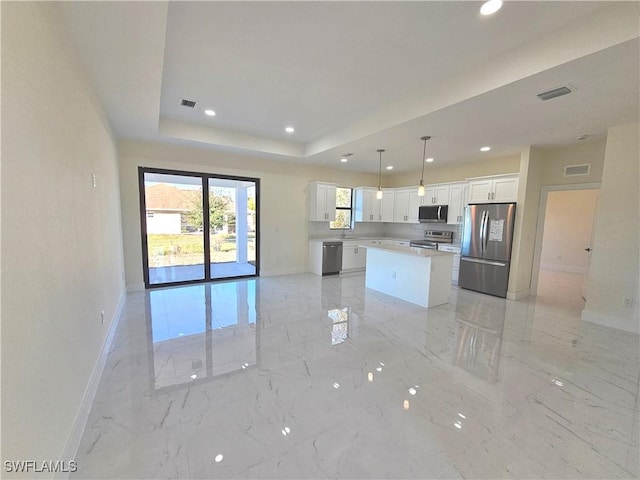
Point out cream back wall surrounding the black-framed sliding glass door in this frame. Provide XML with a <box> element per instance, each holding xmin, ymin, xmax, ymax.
<box><xmin>119</xmin><ymin>141</ymin><xmax>378</xmax><ymax>290</ymax></box>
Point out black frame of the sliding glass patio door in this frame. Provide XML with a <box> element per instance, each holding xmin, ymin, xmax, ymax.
<box><xmin>138</xmin><ymin>166</ymin><xmax>260</xmax><ymax>289</ymax></box>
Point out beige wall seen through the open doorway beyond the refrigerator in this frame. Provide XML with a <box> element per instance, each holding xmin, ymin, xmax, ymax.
<box><xmin>540</xmin><ymin>189</ymin><xmax>599</xmax><ymax>273</ymax></box>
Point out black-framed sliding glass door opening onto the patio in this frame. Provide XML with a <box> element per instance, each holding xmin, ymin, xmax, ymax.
<box><xmin>139</xmin><ymin>167</ymin><xmax>259</xmax><ymax>288</ymax></box>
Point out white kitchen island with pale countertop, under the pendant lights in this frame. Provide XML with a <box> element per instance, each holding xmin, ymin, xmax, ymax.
<box><xmin>362</xmin><ymin>245</ymin><xmax>453</xmax><ymax>308</ymax></box>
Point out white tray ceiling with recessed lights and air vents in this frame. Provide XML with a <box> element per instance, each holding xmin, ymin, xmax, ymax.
<box><xmin>52</xmin><ymin>1</ymin><xmax>640</xmax><ymax>172</ymax></box>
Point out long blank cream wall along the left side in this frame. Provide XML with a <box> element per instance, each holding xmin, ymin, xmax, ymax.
<box><xmin>1</xmin><ymin>2</ymin><xmax>124</xmax><ymax>472</ymax></box>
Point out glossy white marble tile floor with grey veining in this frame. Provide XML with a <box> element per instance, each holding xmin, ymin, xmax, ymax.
<box><xmin>71</xmin><ymin>274</ymin><xmax>640</xmax><ymax>479</ymax></box>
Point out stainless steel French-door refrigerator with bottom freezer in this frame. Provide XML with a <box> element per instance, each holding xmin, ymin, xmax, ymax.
<box><xmin>458</xmin><ymin>203</ymin><xmax>516</xmax><ymax>298</ymax></box>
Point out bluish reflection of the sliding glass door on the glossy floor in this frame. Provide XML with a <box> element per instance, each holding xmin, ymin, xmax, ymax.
<box><xmin>146</xmin><ymin>280</ymin><xmax>258</xmax><ymax>390</ymax></box>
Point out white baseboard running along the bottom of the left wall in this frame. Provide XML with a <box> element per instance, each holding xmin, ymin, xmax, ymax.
<box><xmin>53</xmin><ymin>293</ymin><xmax>127</xmax><ymax>479</ymax></box>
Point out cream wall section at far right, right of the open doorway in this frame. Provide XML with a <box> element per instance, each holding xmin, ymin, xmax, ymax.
<box><xmin>582</xmin><ymin>123</ymin><xmax>640</xmax><ymax>333</ymax></box>
